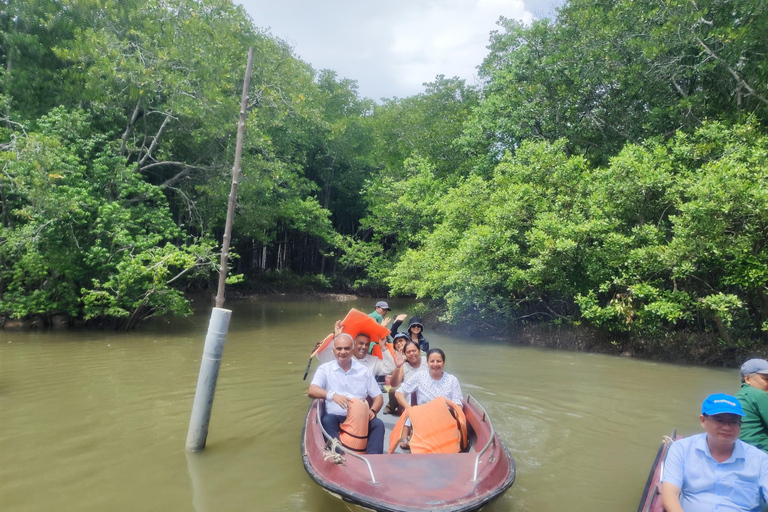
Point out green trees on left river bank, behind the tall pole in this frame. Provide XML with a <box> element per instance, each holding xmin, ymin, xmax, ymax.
<box><xmin>0</xmin><ymin>0</ymin><xmax>360</xmax><ymax>327</ymax></box>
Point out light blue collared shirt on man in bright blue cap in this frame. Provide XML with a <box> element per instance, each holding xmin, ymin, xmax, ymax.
<box><xmin>662</xmin><ymin>433</ymin><xmax>768</xmax><ymax>512</ymax></box>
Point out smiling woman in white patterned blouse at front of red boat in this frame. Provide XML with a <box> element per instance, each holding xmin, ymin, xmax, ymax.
<box><xmin>395</xmin><ymin>348</ymin><xmax>463</xmax><ymax>449</ymax></box>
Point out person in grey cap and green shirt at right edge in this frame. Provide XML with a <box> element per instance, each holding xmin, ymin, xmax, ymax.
<box><xmin>736</xmin><ymin>359</ymin><xmax>768</xmax><ymax>452</ymax></box>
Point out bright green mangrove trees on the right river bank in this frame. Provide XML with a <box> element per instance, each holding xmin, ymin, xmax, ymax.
<box><xmin>352</xmin><ymin>0</ymin><xmax>768</xmax><ymax>352</ymax></box>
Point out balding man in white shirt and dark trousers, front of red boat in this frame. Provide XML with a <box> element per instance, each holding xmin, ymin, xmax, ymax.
<box><xmin>307</xmin><ymin>333</ymin><xmax>384</xmax><ymax>454</ymax></box>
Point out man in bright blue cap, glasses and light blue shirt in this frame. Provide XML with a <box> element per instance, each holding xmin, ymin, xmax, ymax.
<box><xmin>661</xmin><ymin>393</ymin><xmax>768</xmax><ymax>512</ymax></box>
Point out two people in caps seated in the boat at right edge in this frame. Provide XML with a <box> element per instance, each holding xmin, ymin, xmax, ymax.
<box><xmin>661</xmin><ymin>359</ymin><xmax>768</xmax><ymax>512</ymax></box>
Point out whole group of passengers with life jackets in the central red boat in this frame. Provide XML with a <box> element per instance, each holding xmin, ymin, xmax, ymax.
<box><xmin>307</xmin><ymin>301</ymin><xmax>465</xmax><ymax>454</ymax></box>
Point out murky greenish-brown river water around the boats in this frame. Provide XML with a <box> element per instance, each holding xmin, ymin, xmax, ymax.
<box><xmin>0</xmin><ymin>298</ymin><xmax>739</xmax><ymax>512</ymax></box>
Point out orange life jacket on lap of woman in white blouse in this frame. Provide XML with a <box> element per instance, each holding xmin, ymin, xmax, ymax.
<box><xmin>389</xmin><ymin>396</ymin><xmax>467</xmax><ymax>453</ymax></box>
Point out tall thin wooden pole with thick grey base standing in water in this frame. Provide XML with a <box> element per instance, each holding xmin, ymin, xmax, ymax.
<box><xmin>186</xmin><ymin>48</ymin><xmax>253</xmax><ymax>451</ymax></box>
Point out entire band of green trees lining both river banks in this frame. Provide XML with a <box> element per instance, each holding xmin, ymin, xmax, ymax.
<box><xmin>0</xmin><ymin>0</ymin><xmax>768</xmax><ymax>365</ymax></box>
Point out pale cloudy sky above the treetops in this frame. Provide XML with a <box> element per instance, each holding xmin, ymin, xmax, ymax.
<box><xmin>240</xmin><ymin>0</ymin><xmax>564</xmax><ymax>101</ymax></box>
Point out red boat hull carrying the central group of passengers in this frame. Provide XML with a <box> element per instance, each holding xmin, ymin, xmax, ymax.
<box><xmin>301</xmin><ymin>395</ymin><xmax>515</xmax><ymax>512</ymax></box>
